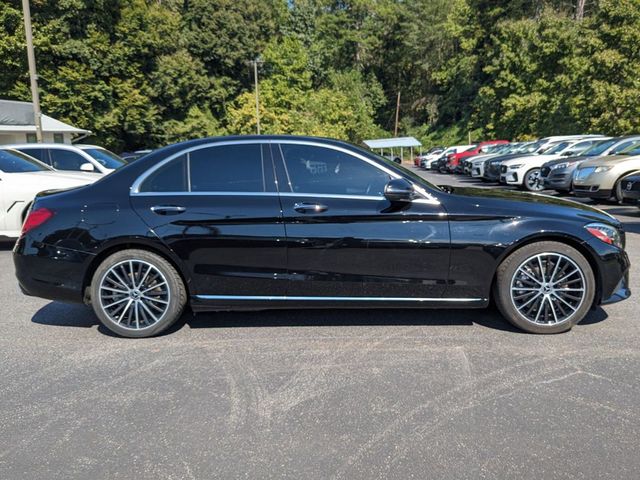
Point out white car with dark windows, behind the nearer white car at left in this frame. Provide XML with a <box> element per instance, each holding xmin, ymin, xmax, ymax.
<box><xmin>6</xmin><ymin>143</ymin><xmax>127</xmax><ymax>175</ymax></box>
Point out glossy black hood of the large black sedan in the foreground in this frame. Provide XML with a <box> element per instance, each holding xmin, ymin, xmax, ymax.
<box><xmin>440</xmin><ymin>185</ymin><xmax>621</xmax><ymax>228</ymax></box>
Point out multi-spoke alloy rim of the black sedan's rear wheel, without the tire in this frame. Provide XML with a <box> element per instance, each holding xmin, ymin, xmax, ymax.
<box><xmin>99</xmin><ymin>260</ymin><xmax>171</xmax><ymax>330</ymax></box>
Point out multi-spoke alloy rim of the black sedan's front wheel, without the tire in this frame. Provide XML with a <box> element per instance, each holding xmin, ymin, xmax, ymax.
<box><xmin>511</xmin><ymin>253</ymin><xmax>586</xmax><ymax>325</ymax></box>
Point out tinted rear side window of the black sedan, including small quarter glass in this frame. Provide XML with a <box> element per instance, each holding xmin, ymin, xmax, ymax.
<box><xmin>140</xmin><ymin>143</ymin><xmax>265</xmax><ymax>193</ymax></box>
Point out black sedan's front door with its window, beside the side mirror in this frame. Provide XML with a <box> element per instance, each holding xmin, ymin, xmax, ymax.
<box><xmin>274</xmin><ymin>142</ymin><xmax>449</xmax><ymax>298</ymax></box>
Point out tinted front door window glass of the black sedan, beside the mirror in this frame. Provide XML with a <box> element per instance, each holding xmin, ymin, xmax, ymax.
<box><xmin>281</xmin><ymin>144</ymin><xmax>392</xmax><ymax>196</ymax></box>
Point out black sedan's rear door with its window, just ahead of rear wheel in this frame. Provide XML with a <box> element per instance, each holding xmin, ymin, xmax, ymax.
<box><xmin>131</xmin><ymin>141</ymin><xmax>286</xmax><ymax>300</ymax></box>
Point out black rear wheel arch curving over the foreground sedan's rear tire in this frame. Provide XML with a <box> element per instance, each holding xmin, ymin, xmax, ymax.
<box><xmin>82</xmin><ymin>238</ymin><xmax>191</xmax><ymax>303</ymax></box>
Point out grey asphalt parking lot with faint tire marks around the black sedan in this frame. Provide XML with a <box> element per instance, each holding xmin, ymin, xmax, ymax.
<box><xmin>0</xmin><ymin>172</ymin><xmax>640</xmax><ymax>479</ymax></box>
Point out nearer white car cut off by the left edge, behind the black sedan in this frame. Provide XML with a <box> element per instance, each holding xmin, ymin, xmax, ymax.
<box><xmin>0</xmin><ymin>146</ymin><xmax>102</xmax><ymax>238</ymax></box>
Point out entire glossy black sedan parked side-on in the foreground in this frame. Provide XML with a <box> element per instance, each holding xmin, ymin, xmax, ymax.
<box><xmin>14</xmin><ymin>136</ymin><xmax>630</xmax><ymax>337</ymax></box>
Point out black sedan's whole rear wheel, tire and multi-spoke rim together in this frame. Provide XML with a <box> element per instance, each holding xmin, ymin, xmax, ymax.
<box><xmin>91</xmin><ymin>249</ymin><xmax>187</xmax><ymax>338</ymax></box>
